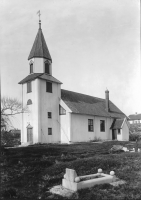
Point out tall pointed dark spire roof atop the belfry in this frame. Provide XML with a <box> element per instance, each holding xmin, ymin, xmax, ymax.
<box><xmin>28</xmin><ymin>27</ymin><xmax>52</xmax><ymax>61</ymax></box>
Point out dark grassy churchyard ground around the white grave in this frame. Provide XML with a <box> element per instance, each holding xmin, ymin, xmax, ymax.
<box><xmin>1</xmin><ymin>141</ymin><xmax>141</xmax><ymax>200</ymax></box>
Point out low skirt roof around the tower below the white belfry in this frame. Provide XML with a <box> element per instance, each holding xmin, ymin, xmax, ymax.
<box><xmin>19</xmin><ymin>73</ymin><xmax>62</xmax><ymax>84</ymax></box>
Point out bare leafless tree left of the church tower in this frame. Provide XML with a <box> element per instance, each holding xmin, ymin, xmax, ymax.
<box><xmin>1</xmin><ymin>97</ymin><xmax>28</xmax><ymax>129</ymax></box>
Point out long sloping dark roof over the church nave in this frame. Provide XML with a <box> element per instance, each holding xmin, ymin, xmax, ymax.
<box><xmin>61</xmin><ymin>90</ymin><xmax>126</xmax><ymax>118</ymax></box>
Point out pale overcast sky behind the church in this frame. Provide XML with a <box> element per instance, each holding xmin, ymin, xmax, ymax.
<box><xmin>0</xmin><ymin>0</ymin><xmax>141</xmax><ymax>128</ymax></box>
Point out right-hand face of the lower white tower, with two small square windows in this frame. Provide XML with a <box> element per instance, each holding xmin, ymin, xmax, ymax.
<box><xmin>39</xmin><ymin>80</ymin><xmax>61</xmax><ymax>143</ymax></box>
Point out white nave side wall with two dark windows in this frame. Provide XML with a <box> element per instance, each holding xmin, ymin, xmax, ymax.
<box><xmin>71</xmin><ymin>113</ymin><xmax>113</xmax><ymax>142</ymax></box>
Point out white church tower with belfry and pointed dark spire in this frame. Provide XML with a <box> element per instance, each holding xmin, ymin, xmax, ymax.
<box><xmin>19</xmin><ymin>19</ymin><xmax>62</xmax><ymax>144</ymax></box>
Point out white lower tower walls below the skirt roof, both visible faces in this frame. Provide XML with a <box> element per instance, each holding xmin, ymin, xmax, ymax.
<box><xmin>21</xmin><ymin>79</ymin><xmax>61</xmax><ymax>143</ymax></box>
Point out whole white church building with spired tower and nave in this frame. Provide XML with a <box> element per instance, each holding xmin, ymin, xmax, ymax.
<box><xmin>19</xmin><ymin>21</ymin><xmax>129</xmax><ymax>144</ymax></box>
